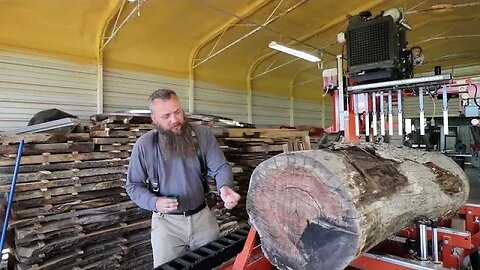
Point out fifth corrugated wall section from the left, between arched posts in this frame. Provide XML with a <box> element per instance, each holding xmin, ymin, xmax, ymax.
<box><xmin>293</xmin><ymin>99</ymin><xmax>322</xmax><ymax>127</ymax></box>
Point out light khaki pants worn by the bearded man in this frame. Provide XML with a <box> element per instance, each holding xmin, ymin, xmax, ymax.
<box><xmin>151</xmin><ymin>207</ymin><xmax>220</xmax><ymax>267</ymax></box>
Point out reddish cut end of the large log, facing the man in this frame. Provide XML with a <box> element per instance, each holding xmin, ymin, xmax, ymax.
<box><xmin>247</xmin><ymin>154</ymin><xmax>358</xmax><ymax>269</ymax></box>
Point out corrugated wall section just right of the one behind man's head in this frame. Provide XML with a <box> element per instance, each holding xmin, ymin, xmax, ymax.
<box><xmin>195</xmin><ymin>84</ymin><xmax>248</xmax><ymax>122</ymax></box>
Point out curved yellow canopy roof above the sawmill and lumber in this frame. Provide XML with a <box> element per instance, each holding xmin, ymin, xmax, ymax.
<box><xmin>0</xmin><ymin>0</ymin><xmax>480</xmax><ymax>99</ymax></box>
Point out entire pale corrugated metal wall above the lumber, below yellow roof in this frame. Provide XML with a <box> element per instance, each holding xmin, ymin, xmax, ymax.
<box><xmin>0</xmin><ymin>52</ymin><xmax>331</xmax><ymax>131</ymax></box>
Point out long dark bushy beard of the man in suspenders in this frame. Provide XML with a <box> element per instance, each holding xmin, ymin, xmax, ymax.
<box><xmin>155</xmin><ymin>123</ymin><xmax>195</xmax><ymax>160</ymax></box>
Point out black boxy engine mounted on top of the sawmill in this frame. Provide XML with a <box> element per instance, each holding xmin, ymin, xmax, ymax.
<box><xmin>345</xmin><ymin>8</ymin><xmax>423</xmax><ymax>83</ymax></box>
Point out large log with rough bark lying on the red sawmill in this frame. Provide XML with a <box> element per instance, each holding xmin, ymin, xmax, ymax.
<box><xmin>247</xmin><ymin>144</ymin><xmax>469</xmax><ymax>270</ymax></box>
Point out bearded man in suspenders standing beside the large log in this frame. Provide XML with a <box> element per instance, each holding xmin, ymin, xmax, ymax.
<box><xmin>125</xmin><ymin>89</ymin><xmax>240</xmax><ymax>267</ymax></box>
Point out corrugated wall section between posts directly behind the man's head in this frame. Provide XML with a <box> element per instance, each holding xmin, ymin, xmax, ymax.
<box><xmin>103</xmin><ymin>70</ymin><xmax>188</xmax><ymax>112</ymax></box>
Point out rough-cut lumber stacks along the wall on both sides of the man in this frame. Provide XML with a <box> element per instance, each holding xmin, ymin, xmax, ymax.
<box><xmin>0</xmin><ymin>113</ymin><xmax>316</xmax><ymax>269</ymax></box>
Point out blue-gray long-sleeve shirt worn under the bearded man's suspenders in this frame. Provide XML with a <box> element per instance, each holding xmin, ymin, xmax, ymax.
<box><xmin>125</xmin><ymin>124</ymin><xmax>233</xmax><ymax>212</ymax></box>
